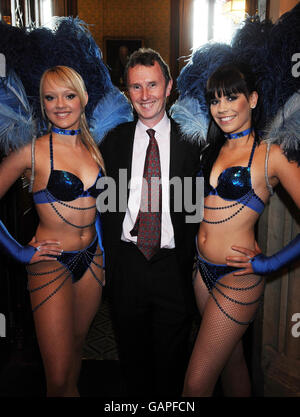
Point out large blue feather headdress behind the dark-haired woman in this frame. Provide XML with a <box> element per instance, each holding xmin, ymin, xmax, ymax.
<box><xmin>171</xmin><ymin>4</ymin><xmax>300</xmax><ymax>163</ymax></box>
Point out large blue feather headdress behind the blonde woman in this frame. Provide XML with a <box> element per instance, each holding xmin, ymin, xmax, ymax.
<box><xmin>0</xmin><ymin>17</ymin><xmax>133</xmax><ymax>152</ymax></box>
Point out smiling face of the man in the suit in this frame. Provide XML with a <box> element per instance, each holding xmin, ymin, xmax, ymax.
<box><xmin>128</xmin><ymin>61</ymin><xmax>172</xmax><ymax>128</ymax></box>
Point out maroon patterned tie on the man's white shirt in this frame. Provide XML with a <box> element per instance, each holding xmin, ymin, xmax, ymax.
<box><xmin>130</xmin><ymin>129</ymin><xmax>162</xmax><ymax>260</ymax></box>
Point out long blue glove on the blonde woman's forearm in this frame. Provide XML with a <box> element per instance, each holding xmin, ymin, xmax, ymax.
<box><xmin>0</xmin><ymin>220</ymin><xmax>36</xmax><ymax>264</ymax></box>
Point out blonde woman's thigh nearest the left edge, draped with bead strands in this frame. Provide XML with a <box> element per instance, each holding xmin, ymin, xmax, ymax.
<box><xmin>27</xmin><ymin>261</ymin><xmax>74</xmax><ymax>372</ymax></box>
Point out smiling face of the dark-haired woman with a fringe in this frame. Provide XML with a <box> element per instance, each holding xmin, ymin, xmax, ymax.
<box><xmin>210</xmin><ymin>91</ymin><xmax>257</xmax><ymax>133</ymax></box>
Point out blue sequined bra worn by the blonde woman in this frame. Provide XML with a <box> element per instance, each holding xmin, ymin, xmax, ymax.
<box><xmin>33</xmin><ymin>134</ymin><xmax>102</xmax><ymax>204</ymax></box>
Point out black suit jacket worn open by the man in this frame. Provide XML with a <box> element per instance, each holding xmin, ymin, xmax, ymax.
<box><xmin>100</xmin><ymin>115</ymin><xmax>200</xmax><ymax>284</ymax></box>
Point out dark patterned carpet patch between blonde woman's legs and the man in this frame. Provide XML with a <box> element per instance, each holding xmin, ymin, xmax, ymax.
<box><xmin>83</xmin><ymin>298</ymin><xmax>118</xmax><ymax>360</ymax></box>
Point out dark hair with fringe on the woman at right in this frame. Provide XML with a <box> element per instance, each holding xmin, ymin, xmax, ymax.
<box><xmin>202</xmin><ymin>63</ymin><xmax>260</xmax><ymax>181</ymax></box>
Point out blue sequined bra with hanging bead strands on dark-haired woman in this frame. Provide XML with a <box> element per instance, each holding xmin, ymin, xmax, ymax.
<box><xmin>203</xmin><ymin>141</ymin><xmax>265</xmax><ymax>224</ymax></box>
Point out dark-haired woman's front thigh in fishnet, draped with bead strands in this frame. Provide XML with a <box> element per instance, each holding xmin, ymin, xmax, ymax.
<box><xmin>190</xmin><ymin>274</ymin><xmax>264</xmax><ymax>378</ymax></box>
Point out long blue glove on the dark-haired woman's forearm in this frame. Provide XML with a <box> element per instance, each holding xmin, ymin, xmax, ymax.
<box><xmin>250</xmin><ymin>234</ymin><xmax>300</xmax><ymax>275</ymax></box>
